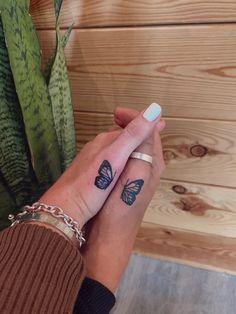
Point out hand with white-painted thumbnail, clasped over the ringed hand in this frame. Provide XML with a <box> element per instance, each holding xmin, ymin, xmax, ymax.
<box><xmin>39</xmin><ymin>104</ymin><xmax>161</xmax><ymax>227</ymax></box>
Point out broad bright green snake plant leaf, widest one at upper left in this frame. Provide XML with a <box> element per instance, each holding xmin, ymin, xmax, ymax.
<box><xmin>1</xmin><ymin>0</ymin><xmax>61</xmax><ymax>189</ymax></box>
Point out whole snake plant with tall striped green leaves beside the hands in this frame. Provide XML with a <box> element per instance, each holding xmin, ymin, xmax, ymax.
<box><xmin>0</xmin><ymin>0</ymin><xmax>76</xmax><ymax>229</ymax></box>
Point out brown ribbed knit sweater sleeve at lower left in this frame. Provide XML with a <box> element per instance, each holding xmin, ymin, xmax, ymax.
<box><xmin>0</xmin><ymin>224</ymin><xmax>85</xmax><ymax>314</ymax></box>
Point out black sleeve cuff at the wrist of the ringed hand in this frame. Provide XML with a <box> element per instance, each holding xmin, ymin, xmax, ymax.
<box><xmin>73</xmin><ymin>278</ymin><xmax>116</xmax><ymax>314</ymax></box>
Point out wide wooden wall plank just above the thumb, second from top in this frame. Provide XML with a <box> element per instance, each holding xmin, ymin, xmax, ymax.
<box><xmin>39</xmin><ymin>24</ymin><xmax>236</xmax><ymax>121</ymax></box>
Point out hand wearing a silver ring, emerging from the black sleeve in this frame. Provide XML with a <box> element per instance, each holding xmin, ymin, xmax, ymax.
<box><xmin>83</xmin><ymin>108</ymin><xmax>165</xmax><ymax>292</ymax></box>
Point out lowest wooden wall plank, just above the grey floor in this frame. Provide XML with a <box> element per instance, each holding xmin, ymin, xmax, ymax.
<box><xmin>134</xmin><ymin>223</ymin><xmax>236</xmax><ymax>274</ymax></box>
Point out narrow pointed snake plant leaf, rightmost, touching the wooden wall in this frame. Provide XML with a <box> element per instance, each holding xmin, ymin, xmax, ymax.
<box><xmin>48</xmin><ymin>3</ymin><xmax>76</xmax><ymax>170</ymax></box>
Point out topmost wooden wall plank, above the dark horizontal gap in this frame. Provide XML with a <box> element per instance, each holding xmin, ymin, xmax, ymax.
<box><xmin>31</xmin><ymin>0</ymin><xmax>236</xmax><ymax>29</ymax></box>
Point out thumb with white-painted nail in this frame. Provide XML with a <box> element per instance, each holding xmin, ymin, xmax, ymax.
<box><xmin>112</xmin><ymin>103</ymin><xmax>161</xmax><ymax>156</ymax></box>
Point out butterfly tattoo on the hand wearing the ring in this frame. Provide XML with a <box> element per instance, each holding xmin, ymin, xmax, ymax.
<box><xmin>121</xmin><ymin>179</ymin><xmax>144</xmax><ymax>206</ymax></box>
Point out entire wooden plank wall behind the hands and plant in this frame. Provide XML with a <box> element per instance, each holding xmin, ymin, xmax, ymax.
<box><xmin>31</xmin><ymin>0</ymin><xmax>236</xmax><ymax>273</ymax></box>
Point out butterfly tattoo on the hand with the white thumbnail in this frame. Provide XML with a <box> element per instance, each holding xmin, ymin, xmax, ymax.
<box><xmin>94</xmin><ymin>160</ymin><xmax>116</xmax><ymax>190</ymax></box>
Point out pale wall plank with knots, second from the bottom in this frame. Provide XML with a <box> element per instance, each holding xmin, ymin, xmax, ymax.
<box><xmin>143</xmin><ymin>180</ymin><xmax>236</xmax><ymax>238</ymax></box>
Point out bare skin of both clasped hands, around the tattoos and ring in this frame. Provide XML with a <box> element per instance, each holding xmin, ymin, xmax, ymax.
<box><xmin>30</xmin><ymin>108</ymin><xmax>165</xmax><ymax>292</ymax></box>
